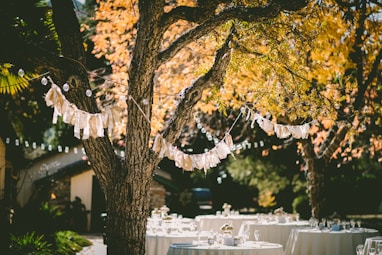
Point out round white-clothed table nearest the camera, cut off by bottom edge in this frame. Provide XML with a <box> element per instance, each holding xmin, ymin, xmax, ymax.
<box><xmin>167</xmin><ymin>242</ymin><xmax>283</xmax><ymax>255</ymax></box>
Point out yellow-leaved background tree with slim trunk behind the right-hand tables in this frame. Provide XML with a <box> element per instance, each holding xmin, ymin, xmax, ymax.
<box><xmin>213</xmin><ymin>1</ymin><xmax>381</xmax><ymax>218</ymax></box>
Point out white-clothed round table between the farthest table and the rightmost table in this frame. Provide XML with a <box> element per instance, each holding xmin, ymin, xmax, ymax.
<box><xmin>239</xmin><ymin>221</ymin><xmax>309</xmax><ymax>248</ymax></box>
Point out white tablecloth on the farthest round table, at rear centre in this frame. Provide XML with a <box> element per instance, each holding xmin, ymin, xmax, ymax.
<box><xmin>195</xmin><ymin>214</ymin><xmax>258</xmax><ymax>235</ymax></box>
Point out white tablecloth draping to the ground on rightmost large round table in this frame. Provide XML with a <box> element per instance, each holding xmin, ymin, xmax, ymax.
<box><xmin>284</xmin><ymin>229</ymin><xmax>379</xmax><ymax>255</ymax></box>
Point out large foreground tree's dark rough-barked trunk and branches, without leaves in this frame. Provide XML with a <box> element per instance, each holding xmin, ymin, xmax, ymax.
<box><xmin>0</xmin><ymin>0</ymin><xmax>306</xmax><ymax>254</ymax></box>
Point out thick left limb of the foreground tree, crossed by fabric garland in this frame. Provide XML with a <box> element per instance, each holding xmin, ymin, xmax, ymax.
<box><xmin>52</xmin><ymin>0</ymin><xmax>123</xmax><ymax>187</ymax></box>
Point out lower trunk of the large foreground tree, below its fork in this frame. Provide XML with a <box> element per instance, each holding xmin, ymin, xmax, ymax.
<box><xmin>106</xmin><ymin>169</ymin><xmax>151</xmax><ymax>255</ymax></box>
